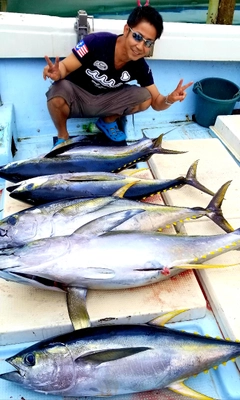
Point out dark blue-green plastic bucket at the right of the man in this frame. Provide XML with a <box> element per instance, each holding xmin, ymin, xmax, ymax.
<box><xmin>193</xmin><ymin>78</ymin><xmax>240</xmax><ymax>127</ymax></box>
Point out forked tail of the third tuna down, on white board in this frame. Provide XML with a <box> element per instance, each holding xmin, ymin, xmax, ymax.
<box><xmin>203</xmin><ymin>181</ymin><xmax>234</xmax><ymax>233</ymax></box>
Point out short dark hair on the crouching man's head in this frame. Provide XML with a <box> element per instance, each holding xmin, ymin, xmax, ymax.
<box><xmin>127</xmin><ymin>6</ymin><xmax>163</xmax><ymax>39</ymax></box>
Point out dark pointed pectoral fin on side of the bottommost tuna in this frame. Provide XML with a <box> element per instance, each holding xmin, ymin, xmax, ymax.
<box><xmin>75</xmin><ymin>347</ymin><xmax>149</xmax><ymax>364</ymax></box>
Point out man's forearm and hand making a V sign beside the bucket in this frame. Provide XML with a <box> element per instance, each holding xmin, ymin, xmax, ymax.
<box><xmin>146</xmin><ymin>79</ymin><xmax>193</xmax><ymax>111</ymax></box>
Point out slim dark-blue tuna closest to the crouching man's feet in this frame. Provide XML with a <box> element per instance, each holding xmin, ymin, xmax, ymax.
<box><xmin>0</xmin><ymin>135</ymin><xmax>184</xmax><ymax>182</ymax></box>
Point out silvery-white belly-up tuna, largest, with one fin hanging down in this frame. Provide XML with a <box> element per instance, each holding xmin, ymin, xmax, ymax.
<box><xmin>0</xmin><ymin>210</ymin><xmax>240</xmax><ymax>327</ymax></box>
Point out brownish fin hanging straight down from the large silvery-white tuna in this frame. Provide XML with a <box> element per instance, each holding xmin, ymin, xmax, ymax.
<box><xmin>67</xmin><ymin>287</ymin><xmax>91</xmax><ymax>330</ymax></box>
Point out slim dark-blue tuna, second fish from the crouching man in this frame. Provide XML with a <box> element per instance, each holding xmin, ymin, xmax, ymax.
<box><xmin>7</xmin><ymin>161</ymin><xmax>213</xmax><ymax>204</ymax></box>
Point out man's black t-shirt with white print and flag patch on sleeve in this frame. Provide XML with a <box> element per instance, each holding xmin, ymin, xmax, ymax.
<box><xmin>66</xmin><ymin>32</ymin><xmax>154</xmax><ymax>94</ymax></box>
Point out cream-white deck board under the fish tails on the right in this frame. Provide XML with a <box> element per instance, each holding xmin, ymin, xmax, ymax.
<box><xmin>149</xmin><ymin>139</ymin><xmax>240</xmax><ymax>368</ymax></box>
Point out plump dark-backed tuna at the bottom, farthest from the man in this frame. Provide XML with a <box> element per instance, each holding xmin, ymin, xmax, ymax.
<box><xmin>0</xmin><ymin>325</ymin><xmax>240</xmax><ymax>400</ymax></box>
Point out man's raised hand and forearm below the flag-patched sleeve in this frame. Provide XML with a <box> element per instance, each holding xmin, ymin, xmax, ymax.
<box><xmin>43</xmin><ymin>53</ymin><xmax>82</xmax><ymax>81</ymax></box>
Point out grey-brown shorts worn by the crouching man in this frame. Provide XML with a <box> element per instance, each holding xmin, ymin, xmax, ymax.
<box><xmin>46</xmin><ymin>79</ymin><xmax>151</xmax><ymax>118</ymax></box>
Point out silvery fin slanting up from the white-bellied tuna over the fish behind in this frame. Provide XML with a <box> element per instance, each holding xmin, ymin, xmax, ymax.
<box><xmin>73</xmin><ymin>210</ymin><xmax>144</xmax><ymax>238</ymax></box>
